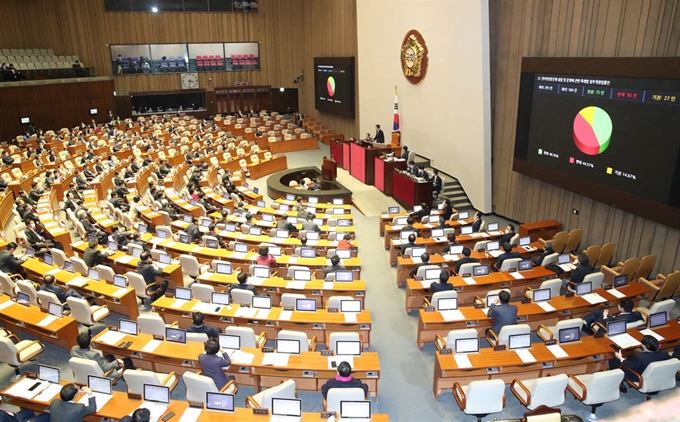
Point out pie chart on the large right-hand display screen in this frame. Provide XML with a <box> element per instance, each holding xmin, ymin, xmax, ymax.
<box><xmin>574</xmin><ymin>106</ymin><xmax>613</xmax><ymax>155</ymax></box>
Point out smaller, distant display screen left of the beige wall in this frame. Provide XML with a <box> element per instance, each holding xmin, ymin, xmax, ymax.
<box><xmin>314</xmin><ymin>57</ymin><xmax>354</xmax><ymax>117</ymax></box>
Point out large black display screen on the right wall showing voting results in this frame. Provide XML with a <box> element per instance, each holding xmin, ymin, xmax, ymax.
<box><xmin>513</xmin><ymin>59</ymin><xmax>680</xmax><ymax>229</ymax></box>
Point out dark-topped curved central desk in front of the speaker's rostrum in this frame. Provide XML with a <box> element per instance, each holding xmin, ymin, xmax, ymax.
<box><xmin>267</xmin><ymin>167</ymin><xmax>352</xmax><ymax>204</ymax></box>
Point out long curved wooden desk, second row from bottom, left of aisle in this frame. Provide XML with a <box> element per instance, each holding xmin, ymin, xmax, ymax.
<box><xmin>92</xmin><ymin>329</ymin><xmax>380</xmax><ymax>397</ymax></box>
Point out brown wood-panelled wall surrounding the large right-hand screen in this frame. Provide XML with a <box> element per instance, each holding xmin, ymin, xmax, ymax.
<box><xmin>490</xmin><ymin>0</ymin><xmax>680</xmax><ymax>273</ymax></box>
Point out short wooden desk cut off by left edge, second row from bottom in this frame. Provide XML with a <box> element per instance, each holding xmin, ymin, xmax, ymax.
<box><xmin>0</xmin><ymin>294</ymin><xmax>78</xmax><ymax>350</ymax></box>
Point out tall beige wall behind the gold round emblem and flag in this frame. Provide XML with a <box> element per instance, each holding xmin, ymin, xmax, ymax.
<box><xmin>357</xmin><ymin>0</ymin><xmax>491</xmax><ymax>211</ymax></box>
